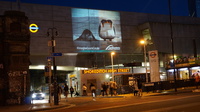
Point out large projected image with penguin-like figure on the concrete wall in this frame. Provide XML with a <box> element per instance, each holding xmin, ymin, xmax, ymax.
<box><xmin>72</xmin><ymin>8</ymin><xmax>122</xmax><ymax>52</ymax></box>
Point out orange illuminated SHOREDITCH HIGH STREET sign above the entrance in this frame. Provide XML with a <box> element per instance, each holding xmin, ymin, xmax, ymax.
<box><xmin>82</xmin><ymin>68</ymin><xmax>130</xmax><ymax>74</ymax></box>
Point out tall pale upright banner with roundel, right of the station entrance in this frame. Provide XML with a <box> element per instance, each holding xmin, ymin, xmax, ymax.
<box><xmin>149</xmin><ymin>50</ymin><xmax>160</xmax><ymax>82</ymax></box>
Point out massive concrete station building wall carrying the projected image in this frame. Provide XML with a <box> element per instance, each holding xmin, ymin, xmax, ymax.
<box><xmin>0</xmin><ymin>1</ymin><xmax>200</xmax><ymax>105</ymax></box>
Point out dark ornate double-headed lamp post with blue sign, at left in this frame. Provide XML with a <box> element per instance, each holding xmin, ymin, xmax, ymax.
<box><xmin>47</xmin><ymin>27</ymin><xmax>58</xmax><ymax>105</ymax></box>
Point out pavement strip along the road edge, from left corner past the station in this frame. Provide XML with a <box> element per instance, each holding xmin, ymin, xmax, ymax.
<box><xmin>0</xmin><ymin>87</ymin><xmax>200</xmax><ymax>112</ymax></box>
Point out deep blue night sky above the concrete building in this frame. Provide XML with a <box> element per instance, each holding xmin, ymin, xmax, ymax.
<box><xmin>0</xmin><ymin>0</ymin><xmax>189</xmax><ymax>16</ymax></box>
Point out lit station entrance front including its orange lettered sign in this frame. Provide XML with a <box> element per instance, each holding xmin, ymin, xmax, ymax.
<box><xmin>79</xmin><ymin>68</ymin><xmax>132</xmax><ymax>95</ymax></box>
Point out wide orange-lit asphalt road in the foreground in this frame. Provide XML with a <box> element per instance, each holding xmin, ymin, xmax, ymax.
<box><xmin>39</xmin><ymin>93</ymin><xmax>200</xmax><ymax>112</ymax></box>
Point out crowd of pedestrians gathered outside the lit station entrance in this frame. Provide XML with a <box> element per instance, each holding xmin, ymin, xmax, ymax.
<box><xmin>54</xmin><ymin>78</ymin><xmax>145</xmax><ymax>101</ymax></box>
